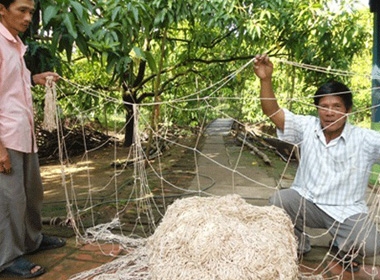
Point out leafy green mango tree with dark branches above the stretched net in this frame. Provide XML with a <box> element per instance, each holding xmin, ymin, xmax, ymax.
<box><xmin>29</xmin><ymin>0</ymin><xmax>367</xmax><ymax>146</ymax></box>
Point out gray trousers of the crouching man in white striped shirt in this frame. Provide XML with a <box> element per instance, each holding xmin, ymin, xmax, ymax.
<box><xmin>269</xmin><ymin>189</ymin><xmax>380</xmax><ymax>257</ymax></box>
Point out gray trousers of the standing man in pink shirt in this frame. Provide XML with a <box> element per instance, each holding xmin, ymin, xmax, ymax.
<box><xmin>0</xmin><ymin>149</ymin><xmax>43</xmax><ymax>271</ymax></box>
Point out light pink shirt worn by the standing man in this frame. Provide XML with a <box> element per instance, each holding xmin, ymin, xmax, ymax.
<box><xmin>0</xmin><ymin>23</ymin><xmax>37</xmax><ymax>153</ymax></box>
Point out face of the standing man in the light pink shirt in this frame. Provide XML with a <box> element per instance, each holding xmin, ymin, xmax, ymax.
<box><xmin>0</xmin><ymin>0</ymin><xmax>34</xmax><ymax>37</ymax></box>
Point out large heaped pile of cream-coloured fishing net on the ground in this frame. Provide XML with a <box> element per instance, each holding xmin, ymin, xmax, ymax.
<box><xmin>72</xmin><ymin>195</ymin><xmax>298</xmax><ymax>280</ymax></box>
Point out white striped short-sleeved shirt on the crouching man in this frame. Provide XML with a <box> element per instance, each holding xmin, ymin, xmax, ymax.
<box><xmin>277</xmin><ymin>109</ymin><xmax>380</xmax><ymax>222</ymax></box>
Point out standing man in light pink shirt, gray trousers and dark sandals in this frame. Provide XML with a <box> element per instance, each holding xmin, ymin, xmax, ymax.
<box><xmin>0</xmin><ymin>0</ymin><xmax>65</xmax><ymax>278</ymax></box>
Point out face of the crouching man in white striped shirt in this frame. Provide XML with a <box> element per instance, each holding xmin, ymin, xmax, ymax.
<box><xmin>318</xmin><ymin>95</ymin><xmax>350</xmax><ymax>140</ymax></box>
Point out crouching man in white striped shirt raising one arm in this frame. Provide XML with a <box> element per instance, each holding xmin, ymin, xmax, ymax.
<box><xmin>254</xmin><ymin>55</ymin><xmax>380</xmax><ymax>272</ymax></box>
